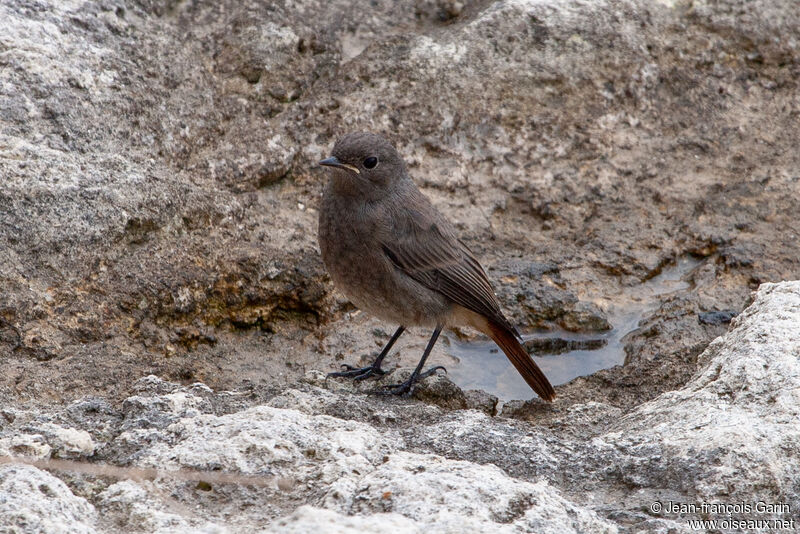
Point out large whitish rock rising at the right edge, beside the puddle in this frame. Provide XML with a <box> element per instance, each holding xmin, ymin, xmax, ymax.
<box><xmin>595</xmin><ymin>282</ymin><xmax>800</xmax><ymax>514</ymax></box>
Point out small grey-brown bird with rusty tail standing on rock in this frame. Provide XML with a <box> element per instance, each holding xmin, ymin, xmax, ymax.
<box><xmin>318</xmin><ymin>132</ymin><xmax>555</xmax><ymax>401</ymax></box>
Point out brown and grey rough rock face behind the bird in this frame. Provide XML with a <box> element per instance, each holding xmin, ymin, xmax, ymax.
<box><xmin>0</xmin><ymin>0</ymin><xmax>800</xmax><ymax>408</ymax></box>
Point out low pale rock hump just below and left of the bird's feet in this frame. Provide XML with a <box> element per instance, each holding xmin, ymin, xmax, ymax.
<box><xmin>127</xmin><ymin>406</ymin><xmax>397</xmax><ymax>483</ymax></box>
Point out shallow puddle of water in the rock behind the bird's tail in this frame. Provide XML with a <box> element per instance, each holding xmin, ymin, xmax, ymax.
<box><xmin>447</xmin><ymin>257</ymin><xmax>699</xmax><ymax>401</ymax></box>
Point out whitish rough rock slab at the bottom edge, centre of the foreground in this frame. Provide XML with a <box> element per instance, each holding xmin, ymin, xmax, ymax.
<box><xmin>324</xmin><ymin>452</ymin><xmax>617</xmax><ymax>534</ymax></box>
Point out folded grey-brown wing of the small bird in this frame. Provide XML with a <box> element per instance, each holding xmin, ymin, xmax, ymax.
<box><xmin>382</xmin><ymin>216</ymin><xmax>506</xmax><ymax>331</ymax></box>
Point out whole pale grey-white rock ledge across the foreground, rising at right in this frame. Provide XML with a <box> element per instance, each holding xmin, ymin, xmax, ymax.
<box><xmin>0</xmin><ymin>282</ymin><xmax>800</xmax><ymax>533</ymax></box>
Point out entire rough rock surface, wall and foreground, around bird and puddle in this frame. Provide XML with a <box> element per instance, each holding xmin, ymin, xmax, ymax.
<box><xmin>0</xmin><ymin>0</ymin><xmax>800</xmax><ymax>532</ymax></box>
